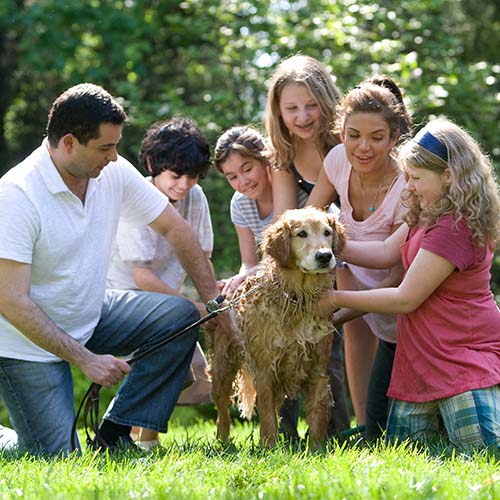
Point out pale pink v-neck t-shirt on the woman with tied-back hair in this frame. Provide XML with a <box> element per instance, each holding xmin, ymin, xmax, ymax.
<box><xmin>324</xmin><ymin>144</ymin><xmax>406</xmax><ymax>342</ymax></box>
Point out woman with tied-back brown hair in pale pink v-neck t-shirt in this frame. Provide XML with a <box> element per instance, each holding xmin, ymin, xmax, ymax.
<box><xmin>308</xmin><ymin>76</ymin><xmax>410</xmax><ymax>439</ymax></box>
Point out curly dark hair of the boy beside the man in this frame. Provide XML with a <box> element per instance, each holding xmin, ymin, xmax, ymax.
<box><xmin>139</xmin><ymin>116</ymin><xmax>210</xmax><ymax>178</ymax></box>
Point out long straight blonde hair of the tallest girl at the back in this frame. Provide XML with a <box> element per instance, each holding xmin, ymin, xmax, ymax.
<box><xmin>264</xmin><ymin>55</ymin><xmax>340</xmax><ymax>169</ymax></box>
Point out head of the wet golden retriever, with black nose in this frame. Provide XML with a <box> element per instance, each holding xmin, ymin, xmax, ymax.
<box><xmin>261</xmin><ymin>207</ymin><xmax>346</xmax><ymax>273</ymax></box>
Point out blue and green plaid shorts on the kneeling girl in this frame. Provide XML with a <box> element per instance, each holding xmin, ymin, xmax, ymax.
<box><xmin>387</xmin><ymin>385</ymin><xmax>500</xmax><ymax>448</ymax></box>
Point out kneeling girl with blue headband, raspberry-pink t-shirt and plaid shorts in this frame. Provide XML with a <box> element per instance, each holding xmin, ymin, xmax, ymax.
<box><xmin>320</xmin><ymin>118</ymin><xmax>500</xmax><ymax>447</ymax></box>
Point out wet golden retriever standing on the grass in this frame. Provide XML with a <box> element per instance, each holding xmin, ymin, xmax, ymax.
<box><xmin>206</xmin><ymin>207</ymin><xmax>345</xmax><ymax>446</ymax></box>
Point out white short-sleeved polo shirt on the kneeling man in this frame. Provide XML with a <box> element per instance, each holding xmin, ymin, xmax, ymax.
<box><xmin>0</xmin><ymin>140</ymin><xmax>168</xmax><ymax>361</ymax></box>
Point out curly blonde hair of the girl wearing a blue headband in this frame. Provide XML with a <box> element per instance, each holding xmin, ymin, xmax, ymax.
<box><xmin>399</xmin><ymin>117</ymin><xmax>500</xmax><ymax>247</ymax></box>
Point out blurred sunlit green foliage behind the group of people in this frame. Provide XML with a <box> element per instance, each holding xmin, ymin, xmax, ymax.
<box><xmin>0</xmin><ymin>0</ymin><xmax>500</xmax><ymax>282</ymax></box>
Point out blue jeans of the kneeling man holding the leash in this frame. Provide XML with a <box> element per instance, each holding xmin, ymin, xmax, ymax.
<box><xmin>0</xmin><ymin>290</ymin><xmax>199</xmax><ymax>455</ymax></box>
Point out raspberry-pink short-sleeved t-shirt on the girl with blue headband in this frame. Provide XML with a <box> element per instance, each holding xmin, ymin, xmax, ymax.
<box><xmin>388</xmin><ymin>216</ymin><xmax>500</xmax><ymax>403</ymax></box>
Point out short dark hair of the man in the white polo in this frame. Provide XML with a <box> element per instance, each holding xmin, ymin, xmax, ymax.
<box><xmin>47</xmin><ymin>83</ymin><xmax>127</xmax><ymax>148</ymax></box>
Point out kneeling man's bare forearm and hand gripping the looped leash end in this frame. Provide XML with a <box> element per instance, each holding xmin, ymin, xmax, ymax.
<box><xmin>0</xmin><ymin>259</ymin><xmax>130</xmax><ymax>387</ymax></box>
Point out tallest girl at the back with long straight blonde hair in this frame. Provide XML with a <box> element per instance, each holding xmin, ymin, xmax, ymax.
<box><xmin>264</xmin><ymin>54</ymin><xmax>350</xmax><ymax>437</ymax></box>
